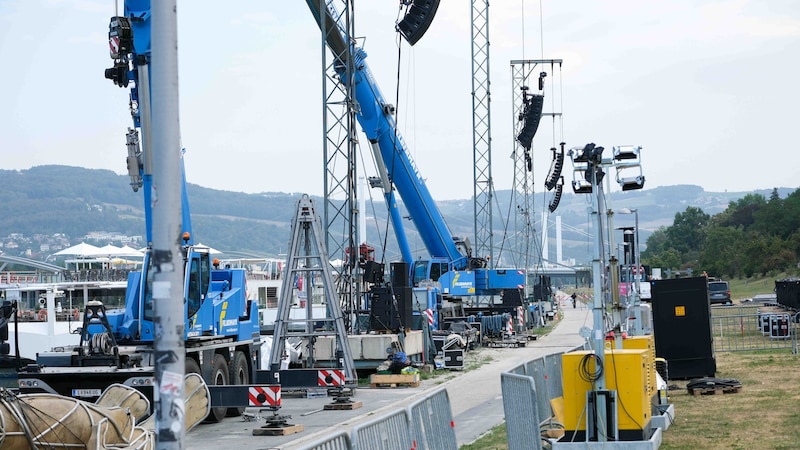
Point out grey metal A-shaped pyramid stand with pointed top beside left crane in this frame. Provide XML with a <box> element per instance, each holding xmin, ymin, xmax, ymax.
<box><xmin>269</xmin><ymin>195</ymin><xmax>358</xmax><ymax>386</ymax></box>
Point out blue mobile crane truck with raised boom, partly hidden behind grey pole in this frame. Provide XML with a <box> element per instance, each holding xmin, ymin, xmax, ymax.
<box><xmin>19</xmin><ymin>0</ymin><xmax>261</xmax><ymax>421</ymax></box>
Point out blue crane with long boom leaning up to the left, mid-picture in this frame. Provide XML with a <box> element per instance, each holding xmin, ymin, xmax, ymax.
<box><xmin>306</xmin><ymin>0</ymin><xmax>525</xmax><ymax>332</ymax></box>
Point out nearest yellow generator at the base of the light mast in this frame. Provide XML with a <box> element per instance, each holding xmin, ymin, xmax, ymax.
<box><xmin>561</xmin><ymin>349</ymin><xmax>656</xmax><ymax>442</ymax></box>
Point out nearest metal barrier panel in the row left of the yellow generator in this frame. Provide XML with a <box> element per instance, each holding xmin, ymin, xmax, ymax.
<box><xmin>500</xmin><ymin>372</ymin><xmax>549</xmax><ymax>450</ymax></box>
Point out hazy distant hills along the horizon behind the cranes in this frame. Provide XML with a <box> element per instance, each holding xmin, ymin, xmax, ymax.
<box><xmin>0</xmin><ymin>165</ymin><xmax>789</xmax><ymax>262</ymax></box>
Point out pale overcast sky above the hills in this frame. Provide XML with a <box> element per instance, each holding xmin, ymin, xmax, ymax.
<box><xmin>0</xmin><ymin>0</ymin><xmax>800</xmax><ymax>200</ymax></box>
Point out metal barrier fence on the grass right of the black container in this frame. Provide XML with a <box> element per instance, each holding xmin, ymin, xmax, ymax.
<box><xmin>711</xmin><ymin>307</ymin><xmax>798</xmax><ymax>353</ymax></box>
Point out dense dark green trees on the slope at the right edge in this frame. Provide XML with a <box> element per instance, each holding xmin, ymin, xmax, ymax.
<box><xmin>641</xmin><ymin>189</ymin><xmax>800</xmax><ymax>278</ymax></box>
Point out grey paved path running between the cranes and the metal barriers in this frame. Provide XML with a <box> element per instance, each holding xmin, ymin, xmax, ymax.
<box><xmin>186</xmin><ymin>300</ymin><xmax>592</xmax><ymax>450</ymax></box>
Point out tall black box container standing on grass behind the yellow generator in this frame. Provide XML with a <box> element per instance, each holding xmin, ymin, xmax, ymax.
<box><xmin>652</xmin><ymin>277</ymin><xmax>717</xmax><ymax>379</ymax></box>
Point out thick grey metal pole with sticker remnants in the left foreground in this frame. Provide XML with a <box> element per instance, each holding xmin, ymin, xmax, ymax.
<box><xmin>151</xmin><ymin>0</ymin><xmax>186</xmax><ymax>450</ymax></box>
